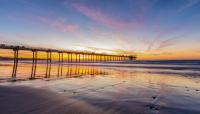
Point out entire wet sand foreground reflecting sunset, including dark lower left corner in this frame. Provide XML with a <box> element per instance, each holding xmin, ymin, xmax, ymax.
<box><xmin>0</xmin><ymin>67</ymin><xmax>200</xmax><ymax>114</ymax></box>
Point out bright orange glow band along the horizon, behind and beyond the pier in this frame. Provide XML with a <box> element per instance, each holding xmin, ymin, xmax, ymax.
<box><xmin>0</xmin><ymin>49</ymin><xmax>200</xmax><ymax>60</ymax></box>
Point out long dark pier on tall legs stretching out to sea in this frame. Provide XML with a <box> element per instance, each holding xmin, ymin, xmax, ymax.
<box><xmin>0</xmin><ymin>44</ymin><xmax>135</xmax><ymax>80</ymax></box>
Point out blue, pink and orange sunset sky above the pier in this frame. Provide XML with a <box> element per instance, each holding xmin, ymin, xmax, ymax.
<box><xmin>0</xmin><ymin>0</ymin><xmax>200</xmax><ymax>60</ymax></box>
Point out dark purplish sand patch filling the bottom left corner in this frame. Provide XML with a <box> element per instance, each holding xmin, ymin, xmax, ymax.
<box><xmin>0</xmin><ymin>86</ymin><xmax>109</xmax><ymax>114</ymax></box>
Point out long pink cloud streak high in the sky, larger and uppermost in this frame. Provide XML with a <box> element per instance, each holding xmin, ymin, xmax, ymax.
<box><xmin>72</xmin><ymin>4</ymin><xmax>138</xmax><ymax>28</ymax></box>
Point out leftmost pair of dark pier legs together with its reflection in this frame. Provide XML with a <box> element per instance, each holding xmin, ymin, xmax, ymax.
<box><xmin>12</xmin><ymin>49</ymin><xmax>19</xmax><ymax>81</ymax></box>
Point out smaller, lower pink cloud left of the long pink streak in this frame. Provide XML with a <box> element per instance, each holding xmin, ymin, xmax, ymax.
<box><xmin>37</xmin><ymin>16</ymin><xmax>79</xmax><ymax>32</ymax></box>
